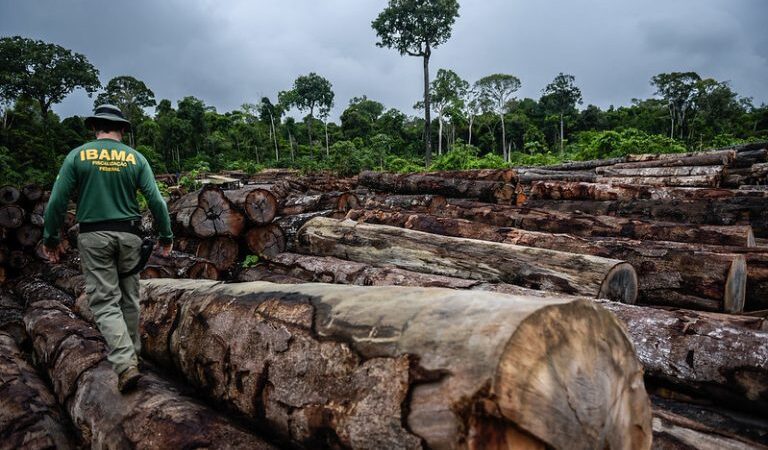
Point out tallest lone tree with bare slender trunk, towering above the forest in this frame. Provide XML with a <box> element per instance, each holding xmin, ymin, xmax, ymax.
<box><xmin>371</xmin><ymin>0</ymin><xmax>459</xmax><ymax>166</ymax></box>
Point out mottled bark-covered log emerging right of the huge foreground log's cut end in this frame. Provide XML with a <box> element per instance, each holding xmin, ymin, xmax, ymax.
<box><xmin>601</xmin><ymin>302</ymin><xmax>768</xmax><ymax>413</ymax></box>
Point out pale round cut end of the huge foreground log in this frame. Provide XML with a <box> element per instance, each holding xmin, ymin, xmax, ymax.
<box><xmin>493</xmin><ymin>300</ymin><xmax>652</xmax><ymax>449</ymax></box>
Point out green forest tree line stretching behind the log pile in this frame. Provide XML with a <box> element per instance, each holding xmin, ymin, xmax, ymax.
<box><xmin>0</xmin><ymin>32</ymin><xmax>768</xmax><ymax>184</ymax></box>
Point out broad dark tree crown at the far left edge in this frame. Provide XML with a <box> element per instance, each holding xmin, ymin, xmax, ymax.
<box><xmin>0</xmin><ymin>36</ymin><xmax>101</xmax><ymax>117</ymax></box>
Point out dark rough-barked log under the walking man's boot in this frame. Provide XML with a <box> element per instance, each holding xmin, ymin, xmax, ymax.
<box><xmin>18</xmin><ymin>289</ymin><xmax>280</xmax><ymax>449</ymax></box>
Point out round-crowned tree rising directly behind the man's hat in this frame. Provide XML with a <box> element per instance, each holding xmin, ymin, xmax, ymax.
<box><xmin>93</xmin><ymin>75</ymin><xmax>156</xmax><ymax>145</ymax></box>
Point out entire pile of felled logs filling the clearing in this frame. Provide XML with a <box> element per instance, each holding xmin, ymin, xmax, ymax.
<box><xmin>0</xmin><ymin>144</ymin><xmax>768</xmax><ymax>449</ymax></box>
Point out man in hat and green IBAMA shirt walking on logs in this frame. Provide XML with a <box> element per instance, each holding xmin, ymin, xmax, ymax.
<box><xmin>43</xmin><ymin>105</ymin><xmax>173</xmax><ymax>392</ymax></box>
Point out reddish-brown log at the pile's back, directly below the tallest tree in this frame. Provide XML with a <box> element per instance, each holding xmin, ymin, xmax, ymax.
<box><xmin>358</xmin><ymin>171</ymin><xmax>515</xmax><ymax>203</ymax></box>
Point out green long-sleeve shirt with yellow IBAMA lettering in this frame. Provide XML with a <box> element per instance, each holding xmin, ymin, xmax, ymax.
<box><xmin>43</xmin><ymin>139</ymin><xmax>173</xmax><ymax>247</ymax></box>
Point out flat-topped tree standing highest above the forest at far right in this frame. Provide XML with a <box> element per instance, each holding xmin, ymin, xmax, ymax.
<box><xmin>651</xmin><ymin>72</ymin><xmax>701</xmax><ymax>138</ymax></box>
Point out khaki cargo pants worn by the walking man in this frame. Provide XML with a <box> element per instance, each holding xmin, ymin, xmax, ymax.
<box><xmin>77</xmin><ymin>231</ymin><xmax>142</xmax><ymax>374</ymax></box>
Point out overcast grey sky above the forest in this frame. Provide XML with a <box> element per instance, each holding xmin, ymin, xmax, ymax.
<box><xmin>0</xmin><ymin>0</ymin><xmax>768</xmax><ymax>121</ymax></box>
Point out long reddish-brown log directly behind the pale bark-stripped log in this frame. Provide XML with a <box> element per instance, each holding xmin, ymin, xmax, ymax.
<box><xmin>353</xmin><ymin>211</ymin><xmax>747</xmax><ymax>313</ymax></box>
